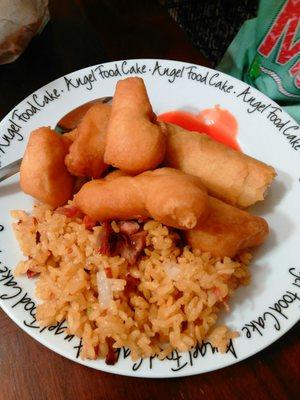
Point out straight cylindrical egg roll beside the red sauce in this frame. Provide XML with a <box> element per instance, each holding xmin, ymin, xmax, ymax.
<box><xmin>164</xmin><ymin>124</ymin><xmax>276</xmax><ymax>208</ymax></box>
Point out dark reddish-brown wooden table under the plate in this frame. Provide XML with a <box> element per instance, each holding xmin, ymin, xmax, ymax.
<box><xmin>0</xmin><ymin>0</ymin><xmax>300</xmax><ymax>400</ymax></box>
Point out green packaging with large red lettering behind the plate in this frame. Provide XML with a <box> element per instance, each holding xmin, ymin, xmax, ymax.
<box><xmin>218</xmin><ymin>0</ymin><xmax>300</xmax><ymax>123</ymax></box>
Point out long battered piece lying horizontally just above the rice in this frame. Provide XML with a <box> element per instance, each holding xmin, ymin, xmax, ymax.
<box><xmin>75</xmin><ymin>168</ymin><xmax>208</xmax><ymax>229</ymax></box>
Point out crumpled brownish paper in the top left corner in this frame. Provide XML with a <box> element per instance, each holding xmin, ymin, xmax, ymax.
<box><xmin>0</xmin><ymin>0</ymin><xmax>49</xmax><ymax>64</ymax></box>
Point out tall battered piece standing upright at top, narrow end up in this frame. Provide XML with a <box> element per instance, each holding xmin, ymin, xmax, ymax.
<box><xmin>104</xmin><ymin>78</ymin><xmax>166</xmax><ymax>175</ymax></box>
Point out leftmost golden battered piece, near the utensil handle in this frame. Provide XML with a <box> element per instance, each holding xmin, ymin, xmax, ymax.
<box><xmin>20</xmin><ymin>127</ymin><xmax>73</xmax><ymax>207</ymax></box>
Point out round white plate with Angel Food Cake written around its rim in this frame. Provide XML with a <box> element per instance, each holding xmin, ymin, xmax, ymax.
<box><xmin>0</xmin><ymin>60</ymin><xmax>300</xmax><ymax>377</ymax></box>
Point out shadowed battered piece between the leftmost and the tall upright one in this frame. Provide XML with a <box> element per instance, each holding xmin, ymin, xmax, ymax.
<box><xmin>65</xmin><ymin>103</ymin><xmax>111</xmax><ymax>178</ymax></box>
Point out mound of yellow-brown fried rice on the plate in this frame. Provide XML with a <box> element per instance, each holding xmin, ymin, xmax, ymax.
<box><xmin>12</xmin><ymin>203</ymin><xmax>251</xmax><ymax>363</ymax></box>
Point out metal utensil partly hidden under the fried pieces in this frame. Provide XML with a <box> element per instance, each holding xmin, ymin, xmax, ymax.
<box><xmin>0</xmin><ymin>96</ymin><xmax>112</xmax><ymax>182</ymax></box>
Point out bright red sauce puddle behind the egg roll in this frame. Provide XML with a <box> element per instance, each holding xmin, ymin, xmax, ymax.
<box><xmin>158</xmin><ymin>106</ymin><xmax>241</xmax><ymax>151</ymax></box>
